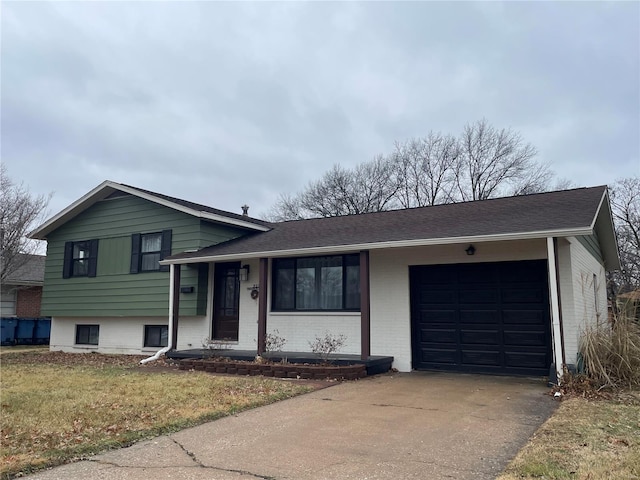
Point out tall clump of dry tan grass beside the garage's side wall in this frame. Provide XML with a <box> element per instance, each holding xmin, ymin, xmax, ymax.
<box><xmin>579</xmin><ymin>314</ymin><xmax>640</xmax><ymax>389</ymax></box>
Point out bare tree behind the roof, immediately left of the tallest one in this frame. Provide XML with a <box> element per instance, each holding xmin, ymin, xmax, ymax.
<box><xmin>392</xmin><ymin>132</ymin><xmax>460</xmax><ymax>208</ymax></box>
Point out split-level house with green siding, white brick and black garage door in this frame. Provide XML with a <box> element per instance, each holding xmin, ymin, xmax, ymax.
<box><xmin>32</xmin><ymin>181</ymin><xmax>619</xmax><ymax>376</ymax></box>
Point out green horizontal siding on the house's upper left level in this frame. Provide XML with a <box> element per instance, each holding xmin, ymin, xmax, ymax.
<box><xmin>42</xmin><ymin>196</ymin><xmax>245</xmax><ymax>317</ymax></box>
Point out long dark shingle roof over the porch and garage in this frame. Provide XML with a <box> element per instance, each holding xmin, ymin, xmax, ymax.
<box><xmin>169</xmin><ymin>186</ymin><xmax>607</xmax><ymax>260</ymax></box>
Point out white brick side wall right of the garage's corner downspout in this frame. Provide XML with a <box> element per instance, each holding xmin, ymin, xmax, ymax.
<box><xmin>558</xmin><ymin>238</ymin><xmax>607</xmax><ymax>364</ymax></box>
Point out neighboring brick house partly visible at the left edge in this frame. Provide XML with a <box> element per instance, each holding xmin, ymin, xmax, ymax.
<box><xmin>0</xmin><ymin>253</ymin><xmax>45</xmax><ymax>318</ymax></box>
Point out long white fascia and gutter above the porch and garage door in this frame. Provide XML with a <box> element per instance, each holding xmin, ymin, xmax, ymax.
<box><xmin>160</xmin><ymin>228</ymin><xmax>593</xmax><ymax>265</ymax></box>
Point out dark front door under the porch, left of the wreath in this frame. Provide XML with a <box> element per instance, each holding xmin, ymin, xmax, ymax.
<box><xmin>213</xmin><ymin>262</ymin><xmax>240</xmax><ymax>340</ymax></box>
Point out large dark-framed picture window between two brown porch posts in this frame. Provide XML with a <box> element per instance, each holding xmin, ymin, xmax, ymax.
<box><xmin>272</xmin><ymin>254</ymin><xmax>360</xmax><ymax>311</ymax></box>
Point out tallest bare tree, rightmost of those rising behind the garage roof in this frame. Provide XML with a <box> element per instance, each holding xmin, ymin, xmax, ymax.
<box><xmin>456</xmin><ymin>119</ymin><xmax>553</xmax><ymax>201</ymax></box>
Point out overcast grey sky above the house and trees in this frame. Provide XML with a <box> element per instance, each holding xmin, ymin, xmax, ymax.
<box><xmin>0</xmin><ymin>1</ymin><xmax>640</xmax><ymax>220</ymax></box>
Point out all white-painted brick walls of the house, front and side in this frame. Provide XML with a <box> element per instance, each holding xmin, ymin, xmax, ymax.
<box><xmin>51</xmin><ymin>235</ymin><xmax>606</xmax><ymax>371</ymax></box>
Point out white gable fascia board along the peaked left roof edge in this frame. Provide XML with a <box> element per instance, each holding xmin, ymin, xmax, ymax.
<box><xmin>28</xmin><ymin>180</ymin><xmax>271</xmax><ymax>240</ymax></box>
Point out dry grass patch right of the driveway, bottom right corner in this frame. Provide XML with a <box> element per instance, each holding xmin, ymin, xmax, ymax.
<box><xmin>498</xmin><ymin>393</ymin><xmax>640</xmax><ymax>480</ymax></box>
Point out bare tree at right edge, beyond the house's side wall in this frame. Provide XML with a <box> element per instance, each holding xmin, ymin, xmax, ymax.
<box><xmin>610</xmin><ymin>176</ymin><xmax>640</xmax><ymax>294</ymax></box>
